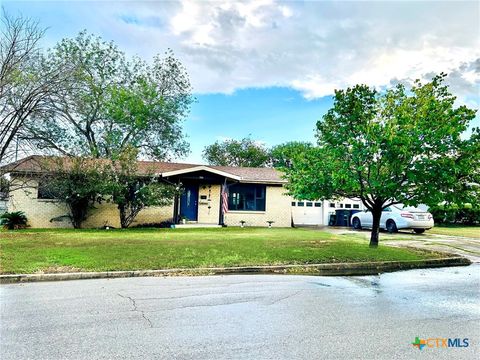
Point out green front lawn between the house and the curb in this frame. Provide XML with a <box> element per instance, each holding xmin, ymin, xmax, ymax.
<box><xmin>0</xmin><ymin>228</ymin><xmax>438</xmax><ymax>274</ymax></box>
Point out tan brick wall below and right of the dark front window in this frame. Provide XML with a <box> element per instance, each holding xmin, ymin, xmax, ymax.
<box><xmin>225</xmin><ymin>186</ymin><xmax>292</xmax><ymax>227</ymax></box>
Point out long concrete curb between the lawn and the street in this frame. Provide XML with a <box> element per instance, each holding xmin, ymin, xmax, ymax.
<box><xmin>0</xmin><ymin>257</ymin><xmax>471</xmax><ymax>284</ymax></box>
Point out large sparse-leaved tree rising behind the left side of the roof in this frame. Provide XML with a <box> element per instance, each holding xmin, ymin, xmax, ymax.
<box><xmin>23</xmin><ymin>31</ymin><xmax>192</xmax><ymax>160</ymax></box>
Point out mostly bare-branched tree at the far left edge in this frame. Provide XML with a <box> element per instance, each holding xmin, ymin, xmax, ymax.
<box><xmin>0</xmin><ymin>9</ymin><xmax>69</xmax><ymax>163</ymax></box>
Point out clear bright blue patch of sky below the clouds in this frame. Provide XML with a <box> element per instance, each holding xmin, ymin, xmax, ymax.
<box><xmin>185</xmin><ymin>87</ymin><xmax>332</xmax><ymax>159</ymax></box>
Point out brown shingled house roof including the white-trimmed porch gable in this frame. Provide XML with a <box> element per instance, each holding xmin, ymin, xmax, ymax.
<box><xmin>3</xmin><ymin>155</ymin><xmax>286</xmax><ymax>184</ymax></box>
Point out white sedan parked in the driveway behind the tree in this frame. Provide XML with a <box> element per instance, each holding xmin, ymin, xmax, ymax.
<box><xmin>350</xmin><ymin>204</ymin><xmax>433</xmax><ymax>234</ymax></box>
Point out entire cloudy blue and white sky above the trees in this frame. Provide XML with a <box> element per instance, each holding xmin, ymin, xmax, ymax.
<box><xmin>0</xmin><ymin>0</ymin><xmax>480</xmax><ymax>162</ymax></box>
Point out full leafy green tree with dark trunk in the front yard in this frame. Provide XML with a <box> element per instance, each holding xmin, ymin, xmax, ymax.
<box><xmin>286</xmin><ymin>74</ymin><xmax>480</xmax><ymax>247</ymax></box>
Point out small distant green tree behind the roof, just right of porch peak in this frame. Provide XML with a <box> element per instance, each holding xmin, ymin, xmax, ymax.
<box><xmin>203</xmin><ymin>137</ymin><xmax>270</xmax><ymax>167</ymax></box>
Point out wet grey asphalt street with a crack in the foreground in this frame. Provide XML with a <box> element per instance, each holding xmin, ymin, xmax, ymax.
<box><xmin>0</xmin><ymin>264</ymin><xmax>480</xmax><ymax>360</ymax></box>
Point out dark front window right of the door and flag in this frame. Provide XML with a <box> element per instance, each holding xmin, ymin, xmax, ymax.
<box><xmin>228</xmin><ymin>184</ymin><xmax>265</xmax><ymax>211</ymax></box>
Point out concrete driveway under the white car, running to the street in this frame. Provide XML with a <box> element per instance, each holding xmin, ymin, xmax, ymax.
<box><xmin>319</xmin><ymin>227</ymin><xmax>480</xmax><ymax>263</ymax></box>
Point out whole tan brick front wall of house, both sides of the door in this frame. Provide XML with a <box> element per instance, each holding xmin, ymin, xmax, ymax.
<box><xmin>8</xmin><ymin>180</ymin><xmax>291</xmax><ymax>228</ymax></box>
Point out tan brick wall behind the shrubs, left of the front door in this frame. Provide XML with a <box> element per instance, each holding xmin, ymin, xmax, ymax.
<box><xmin>8</xmin><ymin>180</ymin><xmax>173</xmax><ymax>228</ymax></box>
